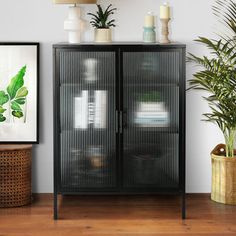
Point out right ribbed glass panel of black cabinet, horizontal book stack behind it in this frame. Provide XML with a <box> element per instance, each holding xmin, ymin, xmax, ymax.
<box><xmin>122</xmin><ymin>51</ymin><xmax>180</xmax><ymax>190</ymax></box>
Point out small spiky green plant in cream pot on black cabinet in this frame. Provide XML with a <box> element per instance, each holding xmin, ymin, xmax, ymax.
<box><xmin>88</xmin><ymin>4</ymin><xmax>116</xmax><ymax>43</ymax></box>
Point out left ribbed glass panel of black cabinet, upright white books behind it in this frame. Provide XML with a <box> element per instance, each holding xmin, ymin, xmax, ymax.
<box><xmin>59</xmin><ymin>50</ymin><xmax>116</xmax><ymax>192</ymax></box>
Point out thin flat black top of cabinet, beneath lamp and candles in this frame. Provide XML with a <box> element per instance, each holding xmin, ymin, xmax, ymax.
<box><xmin>53</xmin><ymin>42</ymin><xmax>186</xmax><ymax>48</ymax></box>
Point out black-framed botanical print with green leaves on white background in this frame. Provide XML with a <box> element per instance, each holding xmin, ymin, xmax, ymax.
<box><xmin>0</xmin><ymin>42</ymin><xmax>39</xmax><ymax>144</ymax></box>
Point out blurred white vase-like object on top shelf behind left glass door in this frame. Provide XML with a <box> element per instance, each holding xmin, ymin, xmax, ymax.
<box><xmin>84</xmin><ymin>58</ymin><xmax>98</xmax><ymax>82</ymax></box>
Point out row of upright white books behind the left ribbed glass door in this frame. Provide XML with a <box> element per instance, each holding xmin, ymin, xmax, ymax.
<box><xmin>74</xmin><ymin>90</ymin><xmax>107</xmax><ymax>129</ymax></box>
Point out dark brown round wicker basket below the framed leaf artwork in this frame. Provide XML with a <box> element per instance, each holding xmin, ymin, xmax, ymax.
<box><xmin>0</xmin><ymin>145</ymin><xmax>32</xmax><ymax>207</ymax></box>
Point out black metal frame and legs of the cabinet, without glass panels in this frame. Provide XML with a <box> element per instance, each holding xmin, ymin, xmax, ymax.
<box><xmin>53</xmin><ymin>43</ymin><xmax>186</xmax><ymax>219</ymax></box>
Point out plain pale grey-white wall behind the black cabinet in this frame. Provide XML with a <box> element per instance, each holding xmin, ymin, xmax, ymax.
<box><xmin>0</xmin><ymin>0</ymin><xmax>223</xmax><ymax>192</ymax></box>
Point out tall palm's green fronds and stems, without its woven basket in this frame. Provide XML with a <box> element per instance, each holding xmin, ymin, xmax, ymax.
<box><xmin>188</xmin><ymin>0</ymin><xmax>236</xmax><ymax>157</ymax></box>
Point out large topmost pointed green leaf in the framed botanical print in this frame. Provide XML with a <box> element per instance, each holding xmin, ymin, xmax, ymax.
<box><xmin>7</xmin><ymin>66</ymin><xmax>26</xmax><ymax>100</ymax></box>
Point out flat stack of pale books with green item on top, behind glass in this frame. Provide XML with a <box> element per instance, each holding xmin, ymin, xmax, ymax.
<box><xmin>134</xmin><ymin>91</ymin><xmax>170</xmax><ymax>127</ymax></box>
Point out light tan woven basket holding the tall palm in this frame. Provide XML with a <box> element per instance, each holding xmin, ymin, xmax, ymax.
<box><xmin>211</xmin><ymin>144</ymin><xmax>236</xmax><ymax>205</ymax></box>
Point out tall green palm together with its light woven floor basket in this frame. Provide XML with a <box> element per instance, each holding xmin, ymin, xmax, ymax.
<box><xmin>188</xmin><ymin>0</ymin><xmax>236</xmax><ymax>204</ymax></box>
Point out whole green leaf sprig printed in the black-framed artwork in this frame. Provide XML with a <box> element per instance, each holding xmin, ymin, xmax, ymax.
<box><xmin>0</xmin><ymin>66</ymin><xmax>28</xmax><ymax>122</ymax></box>
